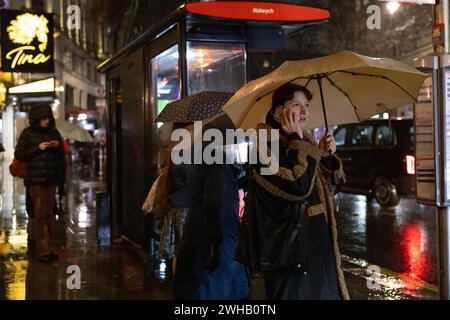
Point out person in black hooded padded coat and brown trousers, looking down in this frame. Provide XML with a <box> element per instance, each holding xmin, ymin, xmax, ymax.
<box><xmin>14</xmin><ymin>105</ymin><xmax>65</xmax><ymax>262</ymax></box>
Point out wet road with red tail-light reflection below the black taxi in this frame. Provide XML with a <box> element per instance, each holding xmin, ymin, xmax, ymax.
<box><xmin>337</xmin><ymin>194</ymin><xmax>438</xmax><ymax>299</ymax></box>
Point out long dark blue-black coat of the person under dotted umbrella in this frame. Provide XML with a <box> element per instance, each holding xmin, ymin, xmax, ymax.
<box><xmin>174</xmin><ymin>144</ymin><xmax>250</xmax><ymax>300</ymax></box>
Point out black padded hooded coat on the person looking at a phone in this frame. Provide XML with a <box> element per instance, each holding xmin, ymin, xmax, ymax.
<box><xmin>14</xmin><ymin>106</ymin><xmax>65</xmax><ymax>187</ymax></box>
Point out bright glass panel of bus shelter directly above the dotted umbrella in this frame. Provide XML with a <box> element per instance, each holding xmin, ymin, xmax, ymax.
<box><xmin>187</xmin><ymin>41</ymin><xmax>246</xmax><ymax>95</ymax></box>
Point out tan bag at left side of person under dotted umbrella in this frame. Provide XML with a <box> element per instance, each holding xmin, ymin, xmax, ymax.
<box><xmin>142</xmin><ymin>167</ymin><xmax>169</xmax><ymax>217</ymax></box>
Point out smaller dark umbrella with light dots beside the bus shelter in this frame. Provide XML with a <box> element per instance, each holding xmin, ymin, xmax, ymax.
<box><xmin>155</xmin><ymin>91</ymin><xmax>233</xmax><ymax>122</ymax></box>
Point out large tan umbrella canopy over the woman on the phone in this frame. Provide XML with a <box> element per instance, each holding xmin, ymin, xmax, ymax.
<box><xmin>223</xmin><ymin>51</ymin><xmax>426</xmax><ymax>129</ymax></box>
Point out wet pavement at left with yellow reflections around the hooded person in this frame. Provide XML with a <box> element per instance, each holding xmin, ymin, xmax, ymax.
<box><xmin>0</xmin><ymin>162</ymin><xmax>170</xmax><ymax>300</ymax></box>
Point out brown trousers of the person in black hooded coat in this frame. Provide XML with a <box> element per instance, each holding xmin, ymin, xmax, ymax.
<box><xmin>29</xmin><ymin>185</ymin><xmax>56</xmax><ymax>257</ymax></box>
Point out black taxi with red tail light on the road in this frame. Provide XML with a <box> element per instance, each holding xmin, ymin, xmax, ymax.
<box><xmin>334</xmin><ymin>120</ymin><xmax>415</xmax><ymax>207</ymax></box>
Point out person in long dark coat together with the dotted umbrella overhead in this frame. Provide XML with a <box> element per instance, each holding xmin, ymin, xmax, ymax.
<box><xmin>156</xmin><ymin>92</ymin><xmax>250</xmax><ymax>300</ymax></box>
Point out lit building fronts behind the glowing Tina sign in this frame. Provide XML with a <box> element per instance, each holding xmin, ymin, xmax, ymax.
<box><xmin>0</xmin><ymin>0</ymin><xmax>105</xmax><ymax>215</ymax></box>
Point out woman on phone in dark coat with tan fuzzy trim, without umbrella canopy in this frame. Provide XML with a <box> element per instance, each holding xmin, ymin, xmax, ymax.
<box><xmin>237</xmin><ymin>83</ymin><xmax>349</xmax><ymax>300</ymax></box>
